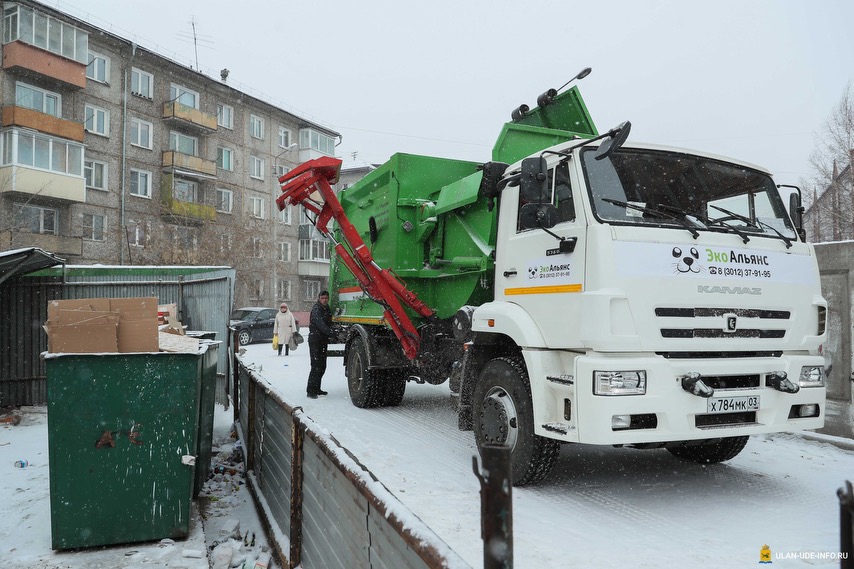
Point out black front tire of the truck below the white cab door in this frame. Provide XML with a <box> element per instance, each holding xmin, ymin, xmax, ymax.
<box><xmin>472</xmin><ymin>357</ymin><xmax>560</xmax><ymax>486</ymax></box>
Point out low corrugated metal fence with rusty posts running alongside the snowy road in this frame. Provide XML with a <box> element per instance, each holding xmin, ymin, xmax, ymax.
<box><xmin>235</xmin><ymin>363</ymin><xmax>470</xmax><ymax>569</ymax></box>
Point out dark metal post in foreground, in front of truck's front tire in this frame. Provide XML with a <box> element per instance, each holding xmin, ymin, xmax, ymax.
<box><xmin>472</xmin><ymin>444</ymin><xmax>513</xmax><ymax>569</ymax></box>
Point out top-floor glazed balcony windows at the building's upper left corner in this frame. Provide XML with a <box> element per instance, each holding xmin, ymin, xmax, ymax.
<box><xmin>3</xmin><ymin>4</ymin><xmax>89</xmax><ymax>64</ymax></box>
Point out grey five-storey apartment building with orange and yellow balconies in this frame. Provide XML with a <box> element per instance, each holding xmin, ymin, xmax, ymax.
<box><xmin>0</xmin><ymin>0</ymin><xmax>339</xmax><ymax>311</ymax></box>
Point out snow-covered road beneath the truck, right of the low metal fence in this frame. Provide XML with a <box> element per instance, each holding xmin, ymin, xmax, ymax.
<box><xmin>239</xmin><ymin>344</ymin><xmax>854</xmax><ymax>569</ymax></box>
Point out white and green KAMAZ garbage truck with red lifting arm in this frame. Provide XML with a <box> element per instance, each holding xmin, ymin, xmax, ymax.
<box><xmin>277</xmin><ymin>70</ymin><xmax>827</xmax><ymax>486</ymax></box>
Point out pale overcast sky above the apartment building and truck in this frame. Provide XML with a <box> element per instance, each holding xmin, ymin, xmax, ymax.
<box><xmin>50</xmin><ymin>0</ymin><xmax>854</xmax><ymax>190</ymax></box>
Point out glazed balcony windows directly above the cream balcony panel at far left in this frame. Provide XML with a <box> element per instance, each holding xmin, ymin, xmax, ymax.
<box><xmin>2</xmin><ymin>129</ymin><xmax>83</xmax><ymax>177</ymax></box>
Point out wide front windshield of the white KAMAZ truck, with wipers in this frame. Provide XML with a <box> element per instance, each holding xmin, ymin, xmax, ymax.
<box><xmin>582</xmin><ymin>148</ymin><xmax>796</xmax><ymax>243</ymax></box>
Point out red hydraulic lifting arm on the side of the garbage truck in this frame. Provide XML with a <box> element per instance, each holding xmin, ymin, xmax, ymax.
<box><xmin>276</xmin><ymin>156</ymin><xmax>435</xmax><ymax>360</ymax></box>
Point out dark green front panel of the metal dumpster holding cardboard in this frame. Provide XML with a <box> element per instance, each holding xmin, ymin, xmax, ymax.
<box><xmin>45</xmin><ymin>351</ymin><xmax>204</xmax><ymax>549</ymax></box>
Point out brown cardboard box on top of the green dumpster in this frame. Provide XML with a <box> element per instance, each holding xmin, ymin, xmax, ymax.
<box><xmin>44</xmin><ymin>297</ymin><xmax>160</xmax><ymax>353</ymax></box>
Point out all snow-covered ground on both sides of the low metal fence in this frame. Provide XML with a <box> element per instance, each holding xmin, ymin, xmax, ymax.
<box><xmin>0</xmin><ymin>344</ymin><xmax>854</xmax><ymax>569</ymax></box>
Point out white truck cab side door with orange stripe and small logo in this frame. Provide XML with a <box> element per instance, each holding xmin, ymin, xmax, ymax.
<box><xmin>495</xmin><ymin>159</ymin><xmax>586</xmax><ymax>348</ymax></box>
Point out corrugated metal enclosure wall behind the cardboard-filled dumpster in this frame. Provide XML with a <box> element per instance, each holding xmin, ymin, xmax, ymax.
<box><xmin>0</xmin><ymin>266</ymin><xmax>235</xmax><ymax>406</ymax></box>
